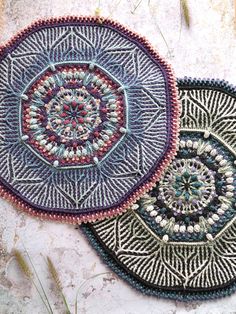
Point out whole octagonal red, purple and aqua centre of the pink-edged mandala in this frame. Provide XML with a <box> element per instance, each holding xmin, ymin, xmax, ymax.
<box><xmin>21</xmin><ymin>64</ymin><xmax>126</xmax><ymax>167</ymax></box>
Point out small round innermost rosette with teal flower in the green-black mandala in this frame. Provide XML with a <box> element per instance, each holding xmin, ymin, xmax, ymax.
<box><xmin>159</xmin><ymin>159</ymin><xmax>215</xmax><ymax>215</ymax></box>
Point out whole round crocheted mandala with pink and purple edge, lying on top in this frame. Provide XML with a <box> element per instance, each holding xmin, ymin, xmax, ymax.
<box><xmin>0</xmin><ymin>17</ymin><xmax>178</xmax><ymax>223</ymax></box>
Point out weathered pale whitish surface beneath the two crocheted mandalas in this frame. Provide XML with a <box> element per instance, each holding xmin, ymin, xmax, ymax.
<box><xmin>0</xmin><ymin>0</ymin><xmax>236</xmax><ymax>314</ymax></box>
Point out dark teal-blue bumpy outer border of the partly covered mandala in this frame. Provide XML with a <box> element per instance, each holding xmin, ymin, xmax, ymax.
<box><xmin>81</xmin><ymin>77</ymin><xmax>236</xmax><ymax>302</ymax></box>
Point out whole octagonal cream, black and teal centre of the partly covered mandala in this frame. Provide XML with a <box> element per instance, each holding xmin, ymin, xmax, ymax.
<box><xmin>139</xmin><ymin>132</ymin><xmax>235</xmax><ymax>242</ymax></box>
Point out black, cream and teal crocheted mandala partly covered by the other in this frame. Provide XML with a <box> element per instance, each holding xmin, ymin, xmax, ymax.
<box><xmin>83</xmin><ymin>79</ymin><xmax>236</xmax><ymax>301</ymax></box>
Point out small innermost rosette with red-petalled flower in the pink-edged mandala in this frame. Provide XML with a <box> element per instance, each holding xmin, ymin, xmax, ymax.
<box><xmin>46</xmin><ymin>87</ymin><xmax>102</xmax><ymax>142</ymax></box>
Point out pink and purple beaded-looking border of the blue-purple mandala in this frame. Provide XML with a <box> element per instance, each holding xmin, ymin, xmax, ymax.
<box><xmin>0</xmin><ymin>16</ymin><xmax>179</xmax><ymax>224</ymax></box>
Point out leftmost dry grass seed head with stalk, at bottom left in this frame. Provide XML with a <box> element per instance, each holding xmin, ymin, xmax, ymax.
<box><xmin>13</xmin><ymin>250</ymin><xmax>53</xmax><ymax>314</ymax></box>
